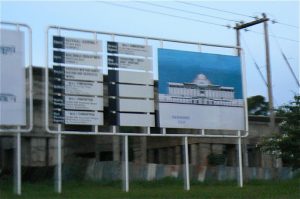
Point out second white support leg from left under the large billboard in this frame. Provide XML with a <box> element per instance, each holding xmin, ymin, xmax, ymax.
<box><xmin>123</xmin><ymin>135</ymin><xmax>129</xmax><ymax>192</ymax></box>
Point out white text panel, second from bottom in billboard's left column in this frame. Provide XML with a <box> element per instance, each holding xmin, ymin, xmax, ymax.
<box><xmin>64</xmin><ymin>95</ymin><xmax>103</xmax><ymax>111</ymax></box>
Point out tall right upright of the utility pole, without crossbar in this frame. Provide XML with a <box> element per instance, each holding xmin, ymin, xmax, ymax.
<box><xmin>262</xmin><ymin>13</ymin><xmax>275</xmax><ymax>131</ymax></box>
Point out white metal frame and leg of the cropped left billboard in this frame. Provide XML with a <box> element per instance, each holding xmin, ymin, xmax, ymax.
<box><xmin>0</xmin><ymin>21</ymin><xmax>33</xmax><ymax>195</ymax></box>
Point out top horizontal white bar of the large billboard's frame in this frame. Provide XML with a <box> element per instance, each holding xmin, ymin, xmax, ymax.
<box><xmin>48</xmin><ymin>25</ymin><xmax>241</xmax><ymax>49</ymax></box>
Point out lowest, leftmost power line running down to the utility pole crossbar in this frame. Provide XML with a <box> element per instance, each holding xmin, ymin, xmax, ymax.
<box><xmin>97</xmin><ymin>1</ymin><xmax>230</xmax><ymax>28</ymax></box>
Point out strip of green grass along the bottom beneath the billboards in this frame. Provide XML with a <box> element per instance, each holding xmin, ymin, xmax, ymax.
<box><xmin>0</xmin><ymin>177</ymin><xmax>300</xmax><ymax>199</ymax></box>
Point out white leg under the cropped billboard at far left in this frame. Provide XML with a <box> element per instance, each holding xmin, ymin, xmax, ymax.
<box><xmin>14</xmin><ymin>127</ymin><xmax>22</xmax><ymax>195</ymax></box>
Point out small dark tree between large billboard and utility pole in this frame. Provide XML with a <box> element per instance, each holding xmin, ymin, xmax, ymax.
<box><xmin>247</xmin><ymin>95</ymin><xmax>268</xmax><ymax>115</ymax></box>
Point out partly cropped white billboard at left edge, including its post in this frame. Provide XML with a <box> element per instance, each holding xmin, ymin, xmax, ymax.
<box><xmin>0</xmin><ymin>21</ymin><xmax>33</xmax><ymax>195</ymax></box>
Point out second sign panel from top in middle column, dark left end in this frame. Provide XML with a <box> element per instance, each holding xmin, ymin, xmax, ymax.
<box><xmin>107</xmin><ymin>56</ymin><xmax>152</xmax><ymax>71</ymax></box>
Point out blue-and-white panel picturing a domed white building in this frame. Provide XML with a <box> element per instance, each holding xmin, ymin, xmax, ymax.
<box><xmin>158</xmin><ymin>49</ymin><xmax>245</xmax><ymax>130</ymax></box>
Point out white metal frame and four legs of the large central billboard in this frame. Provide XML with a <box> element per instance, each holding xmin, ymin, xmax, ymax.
<box><xmin>45</xmin><ymin>25</ymin><xmax>249</xmax><ymax>193</ymax></box>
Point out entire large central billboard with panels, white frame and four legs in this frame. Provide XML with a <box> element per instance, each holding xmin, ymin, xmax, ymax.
<box><xmin>45</xmin><ymin>26</ymin><xmax>248</xmax><ymax>193</ymax></box>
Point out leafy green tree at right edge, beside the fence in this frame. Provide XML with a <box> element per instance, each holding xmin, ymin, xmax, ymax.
<box><xmin>260</xmin><ymin>95</ymin><xmax>300</xmax><ymax>169</ymax></box>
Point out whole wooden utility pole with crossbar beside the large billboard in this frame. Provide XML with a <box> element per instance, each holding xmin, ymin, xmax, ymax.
<box><xmin>234</xmin><ymin>13</ymin><xmax>275</xmax><ymax>131</ymax></box>
